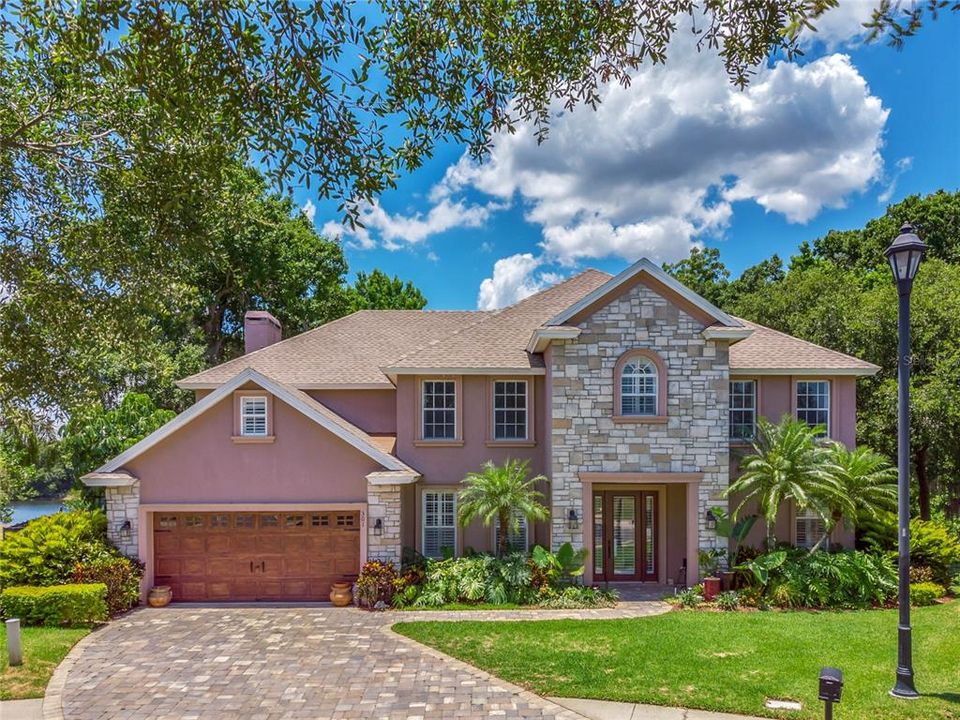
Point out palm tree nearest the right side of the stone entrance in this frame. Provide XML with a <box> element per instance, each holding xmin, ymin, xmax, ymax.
<box><xmin>725</xmin><ymin>415</ymin><xmax>840</xmax><ymax>548</ymax></box>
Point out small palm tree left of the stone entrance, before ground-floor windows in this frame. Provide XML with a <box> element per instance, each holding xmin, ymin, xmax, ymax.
<box><xmin>457</xmin><ymin>459</ymin><xmax>550</xmax><ymax>557</ymax></box>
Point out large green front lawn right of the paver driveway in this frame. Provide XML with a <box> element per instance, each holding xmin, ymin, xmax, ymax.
<box><xmin>394</xmin><ymin>602</ymin><xmax>960</xmax><ymax>720</ymax></box>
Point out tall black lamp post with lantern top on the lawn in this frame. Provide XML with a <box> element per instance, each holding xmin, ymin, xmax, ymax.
<box><xmin>884</xmin><ymin>223</ymin><xmax>927</xmax><ymax>698</ymax></box>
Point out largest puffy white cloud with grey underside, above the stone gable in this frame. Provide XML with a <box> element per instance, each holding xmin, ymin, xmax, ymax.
<box><xmin>440</xmin><ymin>35</ymin><xmax>888</xmax><ymax>264</ymax></box>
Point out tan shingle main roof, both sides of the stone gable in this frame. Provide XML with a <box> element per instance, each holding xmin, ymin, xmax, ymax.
<box><xmin>178</xmin><ymin>270</ymin><xmax>878</xmax><ymax>388</ymax></box>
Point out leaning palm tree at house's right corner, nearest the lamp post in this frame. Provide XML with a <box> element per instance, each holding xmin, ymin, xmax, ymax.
<box><xmin>810</xmin><ymin>442</ymin><xmax>897</xmax><ymax>552</ymax></box>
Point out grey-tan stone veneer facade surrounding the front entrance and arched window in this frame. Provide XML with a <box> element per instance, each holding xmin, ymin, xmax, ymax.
<box><xmin>550</xmin><ymin>284</ymin><xmax>730</xmax><ymax>568</ymax></box>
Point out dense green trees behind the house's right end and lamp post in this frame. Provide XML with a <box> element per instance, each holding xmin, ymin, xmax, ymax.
<box><xmin>665</xmin><ymin>190</ymin><xmax>960</xmax><ymax>518</ymax></box>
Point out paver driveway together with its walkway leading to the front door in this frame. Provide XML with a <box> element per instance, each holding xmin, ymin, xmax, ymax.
<box><xmin>43</xmin><ymin>603</ymin><xmax>666</xmax><ymax>720</ymax></box>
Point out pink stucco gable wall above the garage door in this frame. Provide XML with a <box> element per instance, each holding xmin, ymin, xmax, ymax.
<box><xmin>126</xmin><ymin>390</ymin><xmax>381</xmax><ymax>504</ymax></box>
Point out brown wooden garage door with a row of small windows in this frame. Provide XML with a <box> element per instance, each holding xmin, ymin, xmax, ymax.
<box><xmin>153</xmin><ymin>511</ymin><xmax>360</xmax><ymax>601</ymax></box>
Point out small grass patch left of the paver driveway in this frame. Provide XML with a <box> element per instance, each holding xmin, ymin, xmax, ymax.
<box><xmin>0</xmin><ymin>624</ymin><xmax>90</xmax><ymax>700</ymax></box>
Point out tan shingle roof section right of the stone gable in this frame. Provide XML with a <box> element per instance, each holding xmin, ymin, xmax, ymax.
<box><xmin>730</xmin><ymin>318</ymin><xmax>880</xmax><ymax>375</ymax></box>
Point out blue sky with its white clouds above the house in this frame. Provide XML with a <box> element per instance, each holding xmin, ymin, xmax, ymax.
<box><xmin>295</xmin><ymin>0</ymin><xmax>960</xmax><ymax>309</ymax></box>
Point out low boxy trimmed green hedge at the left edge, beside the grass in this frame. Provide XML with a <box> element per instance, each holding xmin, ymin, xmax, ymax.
<box><xmin>0</xmin><ymin>583</ymin><xmax>108</xmax><ymax>627</ymax></box>
